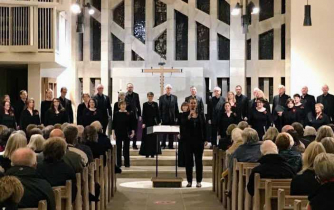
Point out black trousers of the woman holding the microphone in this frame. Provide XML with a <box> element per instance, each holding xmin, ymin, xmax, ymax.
<box><xmin>184</xmin><ymin>142</ymin><xmax>204</xmax><ymax>183</ymax></box>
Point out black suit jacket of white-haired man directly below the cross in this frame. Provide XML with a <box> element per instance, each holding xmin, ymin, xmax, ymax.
<box><xmin>159</xmin><ymin>94</ymin><xmax>179</xmax><ymax>125</ymax></box>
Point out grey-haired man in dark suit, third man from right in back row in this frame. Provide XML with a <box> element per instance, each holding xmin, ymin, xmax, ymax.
<box><xmin>272</xmin><ymin>85</ymin><xmax>290</xmax><ymax>131</ymax></box>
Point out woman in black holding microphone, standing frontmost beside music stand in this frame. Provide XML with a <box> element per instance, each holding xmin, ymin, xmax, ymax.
<box><xmin>184</xmin><ymin>99</ymin><xmax>207</xmax><ymax>187</ymax></box>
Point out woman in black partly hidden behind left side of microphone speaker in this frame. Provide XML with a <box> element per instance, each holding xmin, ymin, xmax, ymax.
<box><xmin>177</xmin><ymin>102</ymin><xmax>189</xmax><ymax>167</ymax></box>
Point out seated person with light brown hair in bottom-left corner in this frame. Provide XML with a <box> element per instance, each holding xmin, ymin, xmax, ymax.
<box><xmin>0</xmin><ymin>176</ymin><xmax>24</xmax><ymax>210</ymax></box>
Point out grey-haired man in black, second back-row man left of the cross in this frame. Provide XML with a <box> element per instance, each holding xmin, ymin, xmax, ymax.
<box><xmin>93</xmin><ymin>84</ymin><xmax>112</xmax><ymax>134</ymax></box>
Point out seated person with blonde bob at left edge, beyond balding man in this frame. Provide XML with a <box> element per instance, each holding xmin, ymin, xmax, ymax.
<box><xmin>0</xmin><ymin>133</ymin><xmax>27</xmax><ymax>172</ymax></box>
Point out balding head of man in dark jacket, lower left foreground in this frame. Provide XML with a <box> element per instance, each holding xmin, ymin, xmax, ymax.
<box><xmin>11</xmin><ymin>147</ymin><xmax>37</xmax><ymax>168</ymax></box>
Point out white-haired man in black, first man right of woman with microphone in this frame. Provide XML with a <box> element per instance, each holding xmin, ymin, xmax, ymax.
<box><xmin>207</xmin><ymin>87</ymin><xmax>225</xmax><ymax>148</ymax></box>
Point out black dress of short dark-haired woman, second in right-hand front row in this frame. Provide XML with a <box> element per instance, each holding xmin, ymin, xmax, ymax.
<box><xmin>249</xmin><ymin>109</ymin><xmax>272</xmax><ymax>139</ymax></box>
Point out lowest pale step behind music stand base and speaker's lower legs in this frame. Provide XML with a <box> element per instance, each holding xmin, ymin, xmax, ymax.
<box><xmin>117</xmin><ymin>166</ymin><xmax>212</xmax><ymax>179</ymax></box>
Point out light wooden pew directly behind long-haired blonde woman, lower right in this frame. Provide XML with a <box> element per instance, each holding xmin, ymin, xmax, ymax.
<box><xmin>277</xmin><ymin>189</ymin><xmax>308</xmax><ymax>210</ymax></box>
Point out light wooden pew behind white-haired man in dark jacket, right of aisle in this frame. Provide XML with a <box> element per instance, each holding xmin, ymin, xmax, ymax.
<box><xmin>253</xmin><ymin>174</ymin><xmax>291</xmax><ymax>210</ymax></box>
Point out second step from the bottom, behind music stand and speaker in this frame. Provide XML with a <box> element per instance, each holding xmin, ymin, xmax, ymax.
<box><xmin>123</xmin><ymin>156</ymin><xmax>212</xmax><ymax>166</ymax></box>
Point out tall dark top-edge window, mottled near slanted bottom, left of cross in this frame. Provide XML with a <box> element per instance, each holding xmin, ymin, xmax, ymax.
<box><xmin>133</xmin><ymin>0</ymin><xmax>145</xmax><ymax>44</ymax></box>
